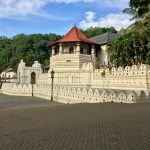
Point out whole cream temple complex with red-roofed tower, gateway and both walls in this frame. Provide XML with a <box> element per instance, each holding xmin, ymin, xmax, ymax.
<box><xmin>1</xmin><ymin>26</ymin><xmax>150</xmax><ymax>103</ymax></box>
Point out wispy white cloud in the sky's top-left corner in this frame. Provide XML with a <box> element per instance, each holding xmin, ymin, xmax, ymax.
<box><xmin>0</xmin><ymin>0</ymin><xmax>95</xmax><ymax>19</ymax></box>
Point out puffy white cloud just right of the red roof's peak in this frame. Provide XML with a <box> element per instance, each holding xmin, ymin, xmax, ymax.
<box><xmin>79</xmin><ymin>11</ymin><xmax>133</xmax><ymax>30</ymax></box>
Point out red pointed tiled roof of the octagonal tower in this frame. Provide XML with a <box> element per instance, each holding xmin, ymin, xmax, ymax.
<box><xmin>58</xmin><ymin>26</ymin><xmax>96</xmax><ymax>44</ymax></box>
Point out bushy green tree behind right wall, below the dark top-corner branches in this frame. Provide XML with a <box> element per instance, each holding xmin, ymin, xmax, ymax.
<box><xmin>109</xmin><ymin>15</ymin><xmax>150</xmax><ymax>66</ymax></box>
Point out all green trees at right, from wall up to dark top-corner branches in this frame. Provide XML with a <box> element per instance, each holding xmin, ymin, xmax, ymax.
<box><xmin>109</xmin><ymin>0</ymin><xmax>150</xmax><ymax>66</ymax></box>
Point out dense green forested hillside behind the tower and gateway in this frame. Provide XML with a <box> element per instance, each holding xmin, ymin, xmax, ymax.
<box><xmin>0</xmin><ymin>27</ymin><xmax>116</xmax><ymax>71</ymax></box>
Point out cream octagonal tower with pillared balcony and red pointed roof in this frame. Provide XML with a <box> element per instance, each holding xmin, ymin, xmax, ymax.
<box><xmin>50</xmin><ymin>26</ymin><xmax>96</xmax><ymax>70</ymax></box>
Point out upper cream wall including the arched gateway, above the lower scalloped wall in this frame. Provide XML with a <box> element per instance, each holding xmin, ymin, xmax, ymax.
<box><xmin>18</xmin><ymin>59</ymin><xmax>150</xmax><ymax>90</ymax></box>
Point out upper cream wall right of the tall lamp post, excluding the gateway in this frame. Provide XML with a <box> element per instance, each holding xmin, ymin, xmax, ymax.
<box><xmin>43</xmin><ymin>62</ymin><xmax>150</xmax><ymax>90</ymax></box>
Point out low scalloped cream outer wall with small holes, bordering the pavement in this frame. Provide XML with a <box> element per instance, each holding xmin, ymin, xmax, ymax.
<box><xmin>2</xmin><ymin>83</ymin><xmax>150</xmax><ymax>103</ymax></box>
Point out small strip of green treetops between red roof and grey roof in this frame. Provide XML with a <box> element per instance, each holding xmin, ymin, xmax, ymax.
<box><xmin>80</xmin><ymin>27</ymin><xmax>117</xmax><ymax>38</ymax></box>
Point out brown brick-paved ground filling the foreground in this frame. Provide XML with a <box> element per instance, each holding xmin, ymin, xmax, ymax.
<box><xmin>0</xmin><ymin>95</ymin><xmax>150</xmax><ymax>150</ymax></box>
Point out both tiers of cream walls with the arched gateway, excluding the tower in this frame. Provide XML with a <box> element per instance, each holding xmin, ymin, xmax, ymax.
<box><xmin>1</xmin><ymin>61</ymin><xmax>150</xmax><ymax>103</ymax></box>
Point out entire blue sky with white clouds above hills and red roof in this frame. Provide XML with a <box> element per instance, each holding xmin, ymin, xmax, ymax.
<box><xmin>0</xmin><ymin>0</ymin><xmax>131</xmax><ymax>37</ymax></box>
